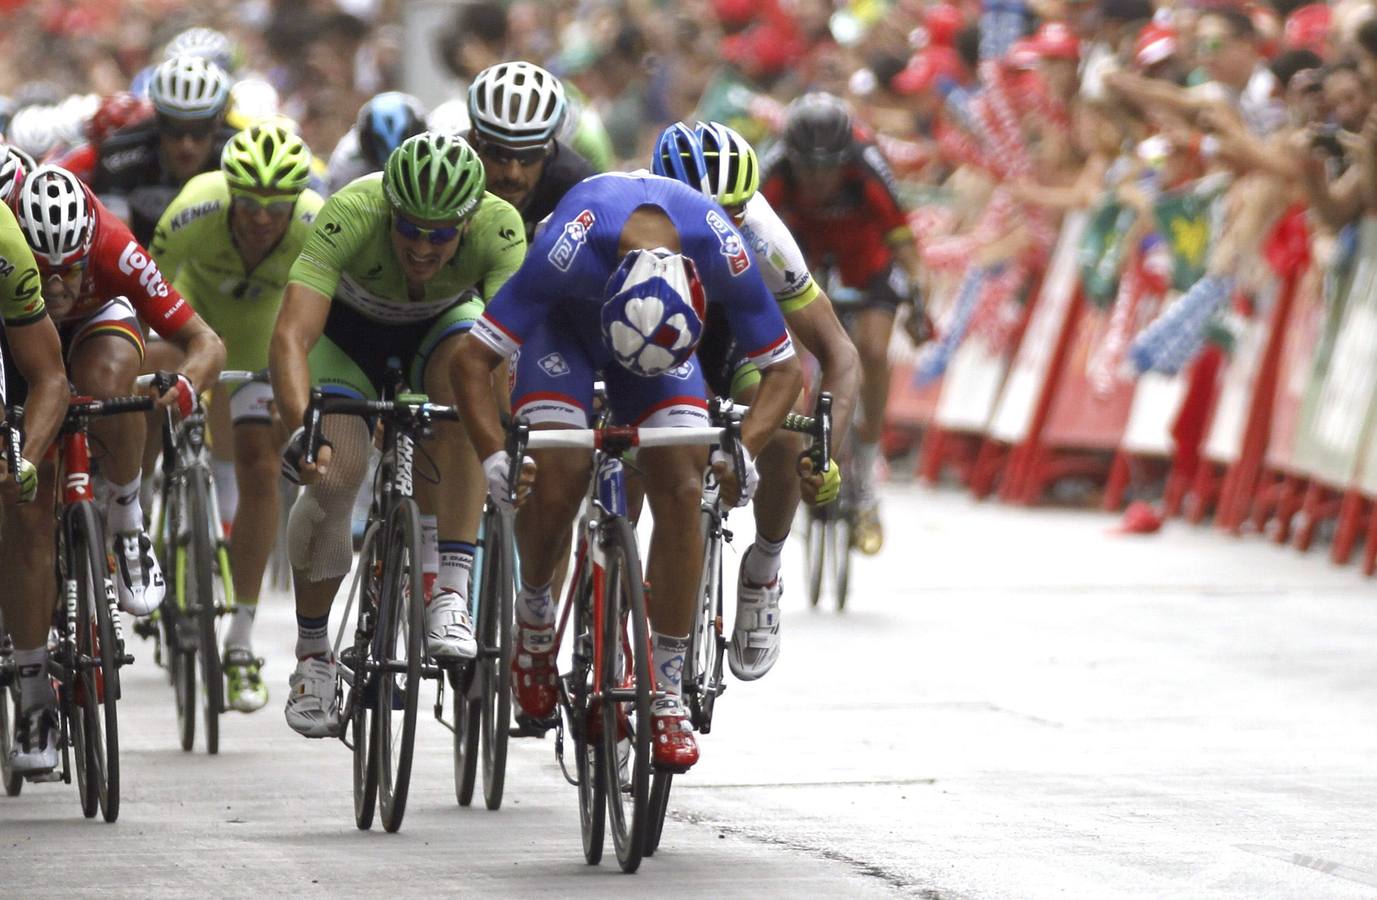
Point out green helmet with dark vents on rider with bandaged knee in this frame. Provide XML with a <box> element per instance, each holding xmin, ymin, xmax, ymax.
<box><xmin>383</xmin><ymin>131</ymin><xmax>487</xmax><ymax>224</ymax></box>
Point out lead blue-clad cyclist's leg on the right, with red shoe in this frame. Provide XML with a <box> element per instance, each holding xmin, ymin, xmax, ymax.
<box><xmin>606</xmin><ymin>359</ymin><xmax>709</xmax><ymax>769</ymax></box>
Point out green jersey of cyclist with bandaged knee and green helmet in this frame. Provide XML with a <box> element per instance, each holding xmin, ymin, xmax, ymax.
<box><xmin>289</xmin><ymin>173</ymin><xmax>526</xmax><ymax>325</ymax></box>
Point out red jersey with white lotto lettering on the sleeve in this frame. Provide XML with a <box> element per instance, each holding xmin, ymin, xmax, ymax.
<box><xmin>48</xmin><ymin>191</ymin><xmax>194</xmax><ymax>337</ymax></box>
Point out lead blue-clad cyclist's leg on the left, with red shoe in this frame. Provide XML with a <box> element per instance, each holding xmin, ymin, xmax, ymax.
<box><xmin>511</xmin><ymin>323</ymin><xmax>593</xmax><ymax>718</ymax></box>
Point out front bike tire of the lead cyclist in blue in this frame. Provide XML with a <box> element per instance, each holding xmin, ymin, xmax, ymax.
<box><xmin>598</xmin><ymin>519</ymin><xmax>654</xmax><ymax>874</ymax></box>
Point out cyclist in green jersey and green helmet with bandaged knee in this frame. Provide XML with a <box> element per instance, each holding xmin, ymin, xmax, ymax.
<box><xmin>270</xmin><ymin>132</ymin><xmax>526</xmax><ymax>738</ymax></box>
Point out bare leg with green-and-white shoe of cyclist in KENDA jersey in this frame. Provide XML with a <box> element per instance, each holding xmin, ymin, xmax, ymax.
<box><xmin>224</xmin><ymin>383</ymin><xmax>281</xmax><ymax>713</ymax></box>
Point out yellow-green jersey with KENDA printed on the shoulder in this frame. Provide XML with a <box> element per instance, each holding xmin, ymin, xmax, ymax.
<box><xmin>149</xmin><ymin>172</ymin><xmax>324</xmax><ymax>372</ymax></box>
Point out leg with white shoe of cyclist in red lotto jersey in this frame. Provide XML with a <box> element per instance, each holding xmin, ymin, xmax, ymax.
<box><xmin>67</xmin><ymin>297</ymin><xmax>164</xmax><ymax>615</ymax></box>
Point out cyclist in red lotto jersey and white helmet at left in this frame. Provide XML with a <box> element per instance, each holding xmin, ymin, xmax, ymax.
<box><xmin>15</xmin><ymin>165</ymin><xmax>224</xmax><ymax>617</ymax></box>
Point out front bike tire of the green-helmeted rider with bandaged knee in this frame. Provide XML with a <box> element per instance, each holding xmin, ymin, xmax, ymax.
<box><xmin>373</xmin><ymin>497</ymin><xmax>425</xmax><ymax>831</ymax></box>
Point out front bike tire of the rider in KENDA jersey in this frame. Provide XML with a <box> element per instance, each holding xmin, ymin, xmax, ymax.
<box><xmin>186</xmin><ymin>471</ymin><xmax>224</xmax><ymax>756</ymax></box>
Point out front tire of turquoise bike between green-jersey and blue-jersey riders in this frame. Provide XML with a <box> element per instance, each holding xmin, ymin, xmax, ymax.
<box><xmin>478</xmin><ymin>511</ymin><xmax>516</xmax><ymax>809</ymax></box>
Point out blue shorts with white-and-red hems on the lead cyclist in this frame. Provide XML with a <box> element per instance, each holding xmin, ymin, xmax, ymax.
<box><xmin>511</xmin><ymin>321</ymin><xmax>711</xmax><ymax>428</ymax></box>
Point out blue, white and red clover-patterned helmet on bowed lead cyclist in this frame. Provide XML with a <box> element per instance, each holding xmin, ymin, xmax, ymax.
<box><xmin>602</xmin><ymin>248</ymin><xmax>706</xmax><ymax>378</ymax></box>
